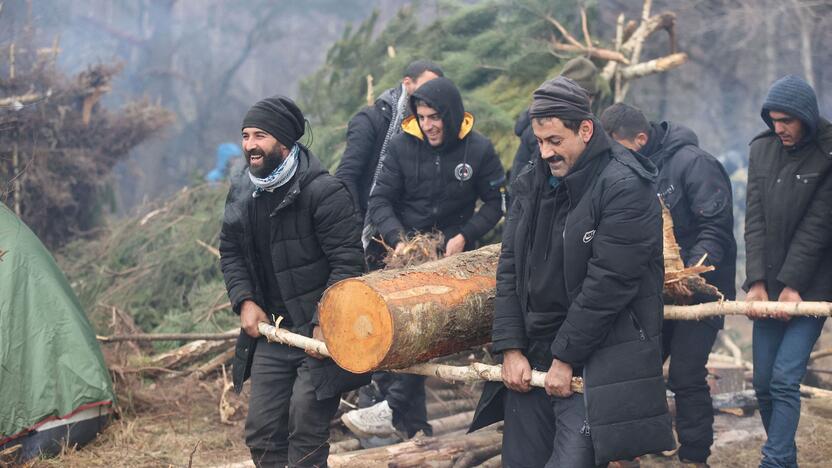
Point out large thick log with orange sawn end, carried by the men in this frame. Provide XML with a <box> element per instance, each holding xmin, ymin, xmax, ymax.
<box><xmin>318</xmin><ymin>245</ymin><xmax>500</xmax><ymax>372</ymax></box>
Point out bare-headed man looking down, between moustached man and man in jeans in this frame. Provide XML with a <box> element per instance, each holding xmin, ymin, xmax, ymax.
<box><xmin>601</xmin><ymin>103</ymin><xmax>737</xmax><ymax>466</ymax></box>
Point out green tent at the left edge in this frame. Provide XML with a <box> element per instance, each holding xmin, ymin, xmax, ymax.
<box><xmin>0</xmin><ymin>203</ymin><xmax>115</xmax><ymax>459</ymax></box>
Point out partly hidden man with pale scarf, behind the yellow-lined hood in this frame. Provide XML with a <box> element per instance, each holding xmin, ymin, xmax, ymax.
<box><xmin>335</xmin><ymin>60</ymin><xmax>444</xmax><ymax>270</ymax></box>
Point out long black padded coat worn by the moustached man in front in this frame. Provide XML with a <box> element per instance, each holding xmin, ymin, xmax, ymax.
<box><xmin>484</xmin><ymin>127</ymin><xmax>674</xmax><ymax>464</ymax></box>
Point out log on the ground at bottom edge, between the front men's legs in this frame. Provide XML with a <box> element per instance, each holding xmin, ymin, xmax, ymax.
<box><xmin>327</xmin><ymin>426</ymin><xmax>503</xmax><ymax>468</ymax></box>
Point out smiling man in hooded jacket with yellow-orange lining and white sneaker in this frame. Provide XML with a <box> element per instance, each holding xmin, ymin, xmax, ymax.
<box><xmin>342</xmin><ymin>77</ymin><xmax>505</xmax><ymax>437</ymax></box>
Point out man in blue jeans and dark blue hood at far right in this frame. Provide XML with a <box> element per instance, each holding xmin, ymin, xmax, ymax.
<box><xmin>743</xmin><ymin>75</ymin><xmax>832</xmax><ymax>467</ymax></box>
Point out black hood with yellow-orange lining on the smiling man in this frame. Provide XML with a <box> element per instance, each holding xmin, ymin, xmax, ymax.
<box><xmin>402</xmin><ymin>77</ymin><xmax>474</xmax><ymax>148</ymax></box>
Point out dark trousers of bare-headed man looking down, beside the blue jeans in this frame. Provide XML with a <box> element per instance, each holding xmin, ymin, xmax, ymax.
<box><xmin>662</xmin><ymin>320</ymin><xmax>719</xmax><ymax>463</ymax></box>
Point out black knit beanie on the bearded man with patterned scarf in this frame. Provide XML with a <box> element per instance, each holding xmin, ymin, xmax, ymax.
<box><xmin>242</xmin><ymin>96</ymin><xmax>306</xmax><ymax>147</ymax></box>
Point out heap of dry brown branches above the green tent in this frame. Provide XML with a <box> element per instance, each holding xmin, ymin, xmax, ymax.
<box><xmin>0</xmin><ymin>37</ymin><xmax>173</xmax><ymax>247</ymax></box>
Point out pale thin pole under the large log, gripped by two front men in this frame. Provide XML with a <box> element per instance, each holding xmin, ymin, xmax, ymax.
<box><xmin>257</xmin><ymin>322</ymin><xmax>584</xmax><ymax>393</ymax></box>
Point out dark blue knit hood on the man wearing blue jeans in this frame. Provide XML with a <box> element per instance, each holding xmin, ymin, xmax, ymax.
<box><xmin>760</xmin><ymin>75</ymin><xmax>820</xmax><ymax>138</ymax></box>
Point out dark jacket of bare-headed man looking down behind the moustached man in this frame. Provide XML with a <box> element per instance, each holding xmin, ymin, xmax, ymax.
<box><xmin>642</xmin><ymin>122</ymin><xmax>737</xmax><ymax>310</ymax></box>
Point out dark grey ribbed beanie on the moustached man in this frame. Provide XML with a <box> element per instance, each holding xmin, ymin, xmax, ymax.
<box><xmin>529</xmin><ymin>76</ymin><xmax>593</xmax><ymax>120</ymax></box>
